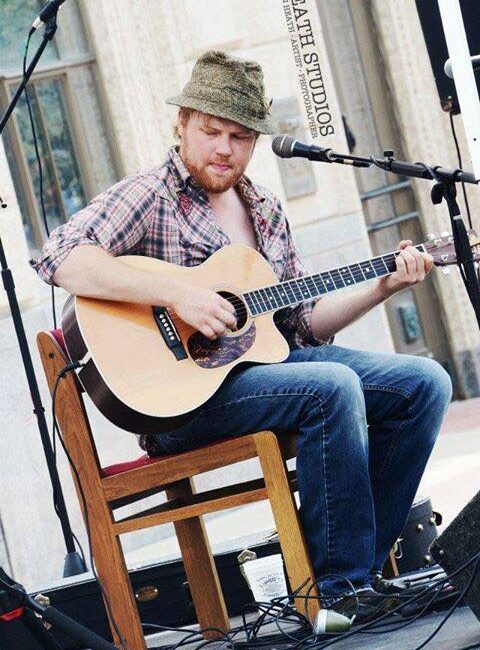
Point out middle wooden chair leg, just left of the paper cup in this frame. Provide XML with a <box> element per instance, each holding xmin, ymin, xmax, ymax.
<box><xmin>166</xmin><ymin>479</ymin><xmax>230</xmax><ymax>639</ymax></box>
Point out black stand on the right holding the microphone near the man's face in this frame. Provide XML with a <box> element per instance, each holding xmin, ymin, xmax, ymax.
<box><xmin>300</xmin><ymin>146</ymin><xmax>480</xmax><ymax>328</ymax></box>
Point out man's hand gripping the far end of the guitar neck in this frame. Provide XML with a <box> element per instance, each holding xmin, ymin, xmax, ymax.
<box><xmin>378</xmin><ymin>239</ymin><xmax>433</xmax><ymax>299</ymax></box>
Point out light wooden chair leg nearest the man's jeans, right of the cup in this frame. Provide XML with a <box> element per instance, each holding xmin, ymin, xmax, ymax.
<box><xmin>255</xmin><ymin>432</ymin><xmax>320</xmax><ymax>618</ymax></box>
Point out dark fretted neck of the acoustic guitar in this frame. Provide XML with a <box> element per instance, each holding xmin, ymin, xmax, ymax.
<box><xmin>243</xmin><ymin>244</ymin><xmax>426</xmax><ymax>316</ymax></box>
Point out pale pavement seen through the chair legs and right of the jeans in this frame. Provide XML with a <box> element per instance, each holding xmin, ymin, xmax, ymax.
<box><xmin>127</xmin><ymin>398</ymin><xmax>480</xmax><ymax>565</ymax></box>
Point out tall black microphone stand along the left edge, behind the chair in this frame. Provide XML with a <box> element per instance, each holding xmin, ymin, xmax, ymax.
<box><xmin>0</xmin><ymin>13</ymin><xmax>87</xmax><ymax>577</ymax></box>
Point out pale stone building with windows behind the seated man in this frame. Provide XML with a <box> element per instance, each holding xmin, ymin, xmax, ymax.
<box><xmin>0</xmin><ymin>0</ymin><xmax>480</xmax><ymax>585</ymax></box>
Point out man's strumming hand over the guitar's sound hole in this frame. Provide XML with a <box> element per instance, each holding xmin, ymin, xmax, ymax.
<box><xmin>172</xmin><ymin>284</ymin><xmax>237</xmax><ymax>341</ymax></box>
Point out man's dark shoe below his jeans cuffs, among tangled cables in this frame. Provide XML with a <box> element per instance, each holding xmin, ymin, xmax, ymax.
<box><xmin>325</xmin><ymin>587</ymin><xmax>400</xmax><ymax>625</ymax></box>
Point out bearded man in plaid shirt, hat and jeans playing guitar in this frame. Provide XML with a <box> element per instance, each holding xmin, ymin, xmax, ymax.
<box><xmin>33</xmin><ymin>51</ymin><xmax>451</xmax><ymax>618</ymax></box>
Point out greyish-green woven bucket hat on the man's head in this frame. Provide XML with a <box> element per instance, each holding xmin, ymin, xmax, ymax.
<box><xmin>166</xmin><ymin>50</ymin><xmax>275</xmax><ymax>133</ymax></box>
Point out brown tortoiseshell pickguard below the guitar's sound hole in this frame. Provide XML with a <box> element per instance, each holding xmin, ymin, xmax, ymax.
<box><xmin>187</xmin><ymin>323</ymin><xmax>256</xmax><ymax>368</ymax></box>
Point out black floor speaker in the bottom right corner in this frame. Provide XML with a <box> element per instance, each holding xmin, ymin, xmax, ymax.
<box><xmin>430</xmin><ymin>492</ymin><xmax>480</xmax><ymax>620</ymax></box>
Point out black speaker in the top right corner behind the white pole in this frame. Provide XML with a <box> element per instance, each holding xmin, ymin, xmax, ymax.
<box><xmin>416</xmin><ymin>0</ymin><xmax>480</xmax><ymax>114</ymax></box>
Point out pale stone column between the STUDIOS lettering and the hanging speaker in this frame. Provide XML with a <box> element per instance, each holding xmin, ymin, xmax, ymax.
<box><xmin>372</xmin><ymin>0</ymin><xmax>480</xmax><ymax>397</ymax></box>
